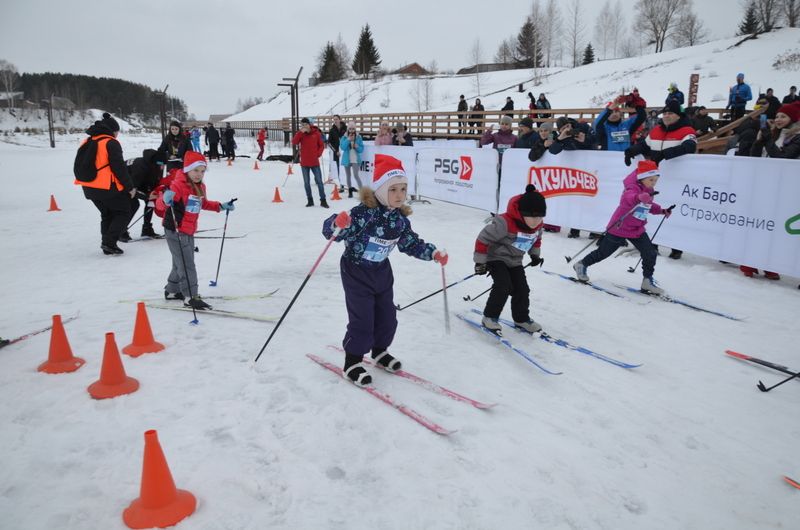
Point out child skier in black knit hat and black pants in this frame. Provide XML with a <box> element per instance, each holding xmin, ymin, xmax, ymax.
<box><xmin>473</xmin><ymin>184</ymin><xmax>547</xmax><ymax>333</ymax></box>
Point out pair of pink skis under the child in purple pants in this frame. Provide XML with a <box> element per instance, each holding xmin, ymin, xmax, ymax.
<box><xmin>306</xmin><ymin>346</ymin><xmax>496</xmax><ymax>436</ymax></box>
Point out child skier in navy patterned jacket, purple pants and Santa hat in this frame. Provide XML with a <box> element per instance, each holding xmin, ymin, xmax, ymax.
<box><xmin>322</xmin><ymin>154</ymin><xmax>448</xmax><ymax>386</ymax></box>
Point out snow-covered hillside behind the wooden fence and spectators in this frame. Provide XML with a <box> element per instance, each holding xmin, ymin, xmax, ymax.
<box><xmin>228</xmin><ymin>28</ymin><xmax>800</xmax><ymax>121</ymax></box>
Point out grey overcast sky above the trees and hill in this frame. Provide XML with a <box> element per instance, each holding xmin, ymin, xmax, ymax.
<box><xmin>0</xmin><ymin>0</ymin><xmax>743</xmax><ymax>119</ymax></box>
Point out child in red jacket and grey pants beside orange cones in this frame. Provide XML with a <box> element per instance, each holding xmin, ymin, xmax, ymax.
<box><xmin>156</xmin><ymin>151</ymin><xmax>234</xmax><ymax>309</ymax></box>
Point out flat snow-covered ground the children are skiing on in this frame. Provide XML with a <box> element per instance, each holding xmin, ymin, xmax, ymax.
<box><xmin>0</xmin><ymin>135</ymin><xmax>800</xmax><ymax>530</ymax></box>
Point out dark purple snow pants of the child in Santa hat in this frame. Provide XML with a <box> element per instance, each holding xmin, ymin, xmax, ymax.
<box><xmin>340</xmin><ymin>257</ymin><xmax>397</xmax><ymax>355</ymax></box>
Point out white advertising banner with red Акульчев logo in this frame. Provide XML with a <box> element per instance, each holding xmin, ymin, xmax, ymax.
<box><xmin>500</xmin><ymin>149</ymin><xmax>631</xmax><ymax>232</ymax></box>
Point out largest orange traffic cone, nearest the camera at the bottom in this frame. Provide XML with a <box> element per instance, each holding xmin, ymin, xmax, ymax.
<box><xmin>122</xmin><ymin>430</ymin><xmax>197</xmax><ymax>528</ymax></box>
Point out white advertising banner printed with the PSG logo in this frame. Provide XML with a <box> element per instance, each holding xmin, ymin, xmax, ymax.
<box><xmin>417</xmin><ymin>148</ymin><xmax>496</xmax><ymax>212</ymax></box>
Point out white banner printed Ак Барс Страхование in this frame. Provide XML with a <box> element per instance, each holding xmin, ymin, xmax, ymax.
<box><xmin>651</xmin><ymin>155</ymin><xmax>800</xmax><ymax>276</ymax></box>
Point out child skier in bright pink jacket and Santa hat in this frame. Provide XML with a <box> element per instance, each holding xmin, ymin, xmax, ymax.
<box><xmin>572</xmin><ymin>160</ymin><xmax>672</xmax><ymax>295</ymax></box>
